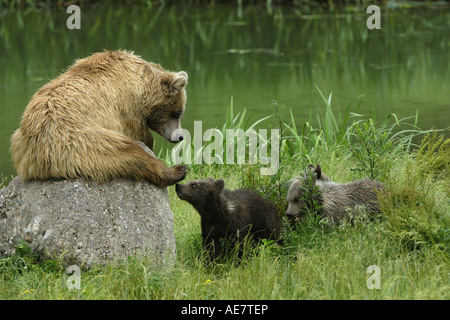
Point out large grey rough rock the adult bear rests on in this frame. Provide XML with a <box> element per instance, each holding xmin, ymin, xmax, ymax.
<box><xmin>0</xmin><ymin>177</ymin><xmax>175</xmax><ymax>268</ymax></box>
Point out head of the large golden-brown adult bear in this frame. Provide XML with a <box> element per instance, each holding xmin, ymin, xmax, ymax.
<box><xmin>142</xmin><ymin>63</ymin><xmax>188</xmax><ymax>143</ymax></box>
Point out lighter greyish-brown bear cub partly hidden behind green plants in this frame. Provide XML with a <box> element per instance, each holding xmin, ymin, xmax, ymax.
<box><xmin>286</xmin><ymin>164</ymin><xmax>383</xmax><ymax>222</ymax></box>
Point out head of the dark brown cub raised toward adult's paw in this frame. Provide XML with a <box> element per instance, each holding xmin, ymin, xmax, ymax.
<box><xmin>175</xmin><ymin>178</ymin><xmax>225</xmax><ymax>210</ymax></box>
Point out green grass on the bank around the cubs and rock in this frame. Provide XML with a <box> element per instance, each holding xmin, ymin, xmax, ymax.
<box><xmin>0</xmin><ymin>95</ymin><xmax>450</xmax><ymax>300</ymax></box>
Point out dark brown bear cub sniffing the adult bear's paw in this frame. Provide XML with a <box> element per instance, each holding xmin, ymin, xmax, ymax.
<box><xmin>175</xmin><ymin>178</ymin><xmax>281</xmax><ymax>256</ymax></box>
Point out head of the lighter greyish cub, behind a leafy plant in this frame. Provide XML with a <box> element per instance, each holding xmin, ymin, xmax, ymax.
<box><xmin>286</xmin><ymin>164</ymin><xmax>331</xmax><ymax>220</ymax></box>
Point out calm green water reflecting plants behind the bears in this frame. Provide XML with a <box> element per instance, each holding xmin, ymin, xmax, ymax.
<box><xmin>0</xmin><ymin>5</ymin><xmax>450</xmax><ymax>176</ymax></box>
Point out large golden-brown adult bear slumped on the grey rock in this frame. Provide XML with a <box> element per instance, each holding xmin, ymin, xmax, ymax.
<box><xmin>11</xmin><ymin>50</ymin><xmax>188</xmax><ymax>186</ymax></box>
